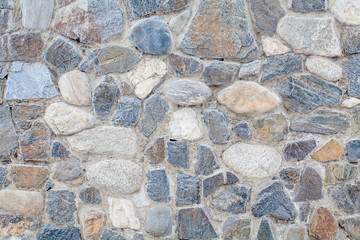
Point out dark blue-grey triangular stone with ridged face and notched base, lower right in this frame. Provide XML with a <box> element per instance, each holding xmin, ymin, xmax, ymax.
<box><xmin>251</xmin><ymin>181</ymin><xmax>296</xmax><ymax>220</ymax></box>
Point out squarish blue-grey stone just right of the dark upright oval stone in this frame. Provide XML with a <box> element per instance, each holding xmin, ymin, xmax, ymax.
<box><xmin>112</xmin><ymin>97</ymin><xmax>141</xmax><ymax>126</ymax></box>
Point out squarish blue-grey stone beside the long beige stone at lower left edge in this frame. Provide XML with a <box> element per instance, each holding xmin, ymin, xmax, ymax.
<box><xmin>46</xmin><ymin>190</ymin><xmax>77</xmax><ymax>224</ymax></box>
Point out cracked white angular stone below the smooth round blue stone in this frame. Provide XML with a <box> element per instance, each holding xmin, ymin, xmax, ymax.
<box><xmin>127</xmin><ymin>58</ymin><xmax>167</xmax><ymax>99</ymax></box>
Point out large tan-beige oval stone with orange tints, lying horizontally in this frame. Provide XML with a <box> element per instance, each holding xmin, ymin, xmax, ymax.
<box><xmin>217</xmin><ymin>81</ymin><xmax>281</xmax><ymax>114</ymax></box>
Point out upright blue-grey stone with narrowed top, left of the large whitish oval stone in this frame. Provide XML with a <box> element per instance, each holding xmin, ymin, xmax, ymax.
<box><xmin>194</xmin><ymin>145</ymin><xmax>219</xmax><ymax>175</ymax></box>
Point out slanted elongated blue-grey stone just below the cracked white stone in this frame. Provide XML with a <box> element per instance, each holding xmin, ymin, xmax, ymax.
<box><xmin>139</xmin><ymin>94</ymin><xmax>169</xmax><ymax>137</ymax></box>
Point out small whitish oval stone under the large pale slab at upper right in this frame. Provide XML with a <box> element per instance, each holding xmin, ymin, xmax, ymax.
<box><xmin>305</xmin><ymin>57</ymin><xmax>342</xmax><ymax>82</ymax></box>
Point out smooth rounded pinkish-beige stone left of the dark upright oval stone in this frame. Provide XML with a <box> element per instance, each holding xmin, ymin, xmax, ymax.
<box><xmin>59</xmin><ymin>70</ymin><xmax>91</xmax><ymax>106</ymax></box>
